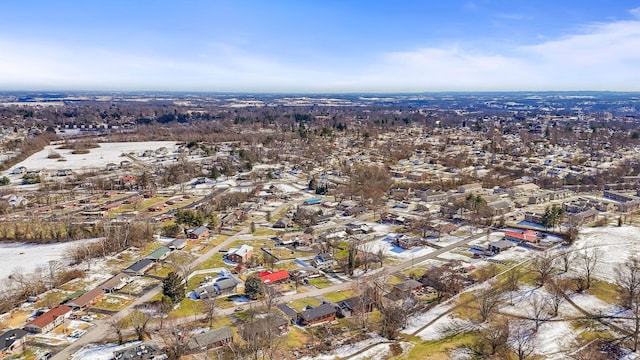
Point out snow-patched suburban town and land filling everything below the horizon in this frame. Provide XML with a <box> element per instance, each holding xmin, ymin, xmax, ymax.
<box><xmin>0</xmin><ymin>92</ymin><xmax>640</xmax><ymax>360</ymax></box>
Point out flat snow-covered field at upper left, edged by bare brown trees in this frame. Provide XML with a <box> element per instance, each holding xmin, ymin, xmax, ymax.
<box><xmin>6</xmin><ymin>141</ymin><xmax>177</xmax><ymax>170</ymax></box>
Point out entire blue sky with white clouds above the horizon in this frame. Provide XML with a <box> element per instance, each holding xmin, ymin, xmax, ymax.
<box><xmin>0</xmin><ymin>0</ymin><xmax>640</xmax><ymax>92</ymax></box>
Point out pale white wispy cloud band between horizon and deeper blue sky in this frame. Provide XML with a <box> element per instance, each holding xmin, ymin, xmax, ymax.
<box><xmin>0</xmin><ymin>8</ymin><xmax>640</xmax><ymax>91</ymax></box>
